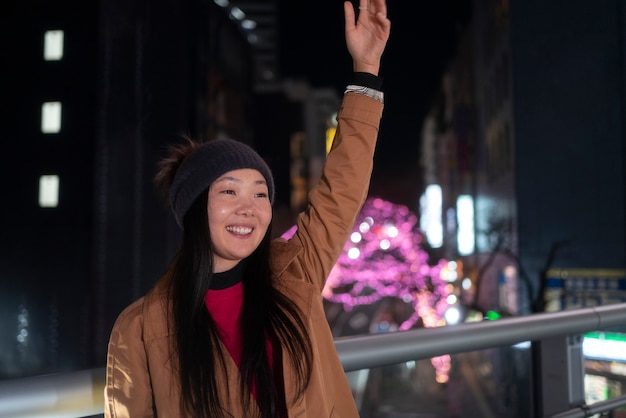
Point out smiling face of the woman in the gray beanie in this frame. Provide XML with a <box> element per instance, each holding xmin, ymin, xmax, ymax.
<box><xmin>207</xmin><ymin>168</ymin><xmax>272</xmax><ymax>273</ymax></box>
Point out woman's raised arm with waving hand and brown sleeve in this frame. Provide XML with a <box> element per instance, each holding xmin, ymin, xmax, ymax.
<box><xmin>294</xmin><ymin>0</ymin><xmax>390</xmax><ymax>292</ymax></box>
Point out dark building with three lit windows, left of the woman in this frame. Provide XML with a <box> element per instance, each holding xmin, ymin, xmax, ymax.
<box><xmin>0</xmin><ymin>0</ymin><xmax>288</xmax><ymax>379</ymax></box>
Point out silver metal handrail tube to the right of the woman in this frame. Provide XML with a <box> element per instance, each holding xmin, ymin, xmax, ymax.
<box><xmin>335</xmin><ymin>303</ymin><xmax>626</xmax><ymax>371</ymax></box>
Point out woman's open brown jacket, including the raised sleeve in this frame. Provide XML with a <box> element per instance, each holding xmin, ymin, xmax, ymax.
<box><xmin>104</xmin><ymin>93</ymin><xmax>383</xmax><ymax>418</ymax></box>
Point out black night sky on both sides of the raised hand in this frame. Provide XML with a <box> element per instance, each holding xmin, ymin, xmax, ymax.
<box><xmin>278</xmin><ymin>0</ymin><xmax>471</xmax><ymax>186</ymax></box>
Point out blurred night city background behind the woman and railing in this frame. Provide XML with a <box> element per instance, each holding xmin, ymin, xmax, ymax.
<box><xmin>0</xmin><ymin>0</ymin><xmax>626</xmax><ymax>416</ymax></box>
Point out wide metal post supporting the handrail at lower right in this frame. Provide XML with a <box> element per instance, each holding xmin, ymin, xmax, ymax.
<box><xmin>532</xmin><ymin>334</ymin><xmax>585</xmax><ymax>418</ymax></box>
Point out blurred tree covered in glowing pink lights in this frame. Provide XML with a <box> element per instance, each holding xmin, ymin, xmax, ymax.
<box><xmin>323</xmin><ymin>197</ymin><xmax>450</xmax><ymax>330</ymax></box>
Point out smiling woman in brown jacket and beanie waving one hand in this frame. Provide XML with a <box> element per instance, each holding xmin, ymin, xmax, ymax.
<box><xmin>105</xmin><ymin>0</ymin><xmax>390</xmax><ymax>418</ymax></box>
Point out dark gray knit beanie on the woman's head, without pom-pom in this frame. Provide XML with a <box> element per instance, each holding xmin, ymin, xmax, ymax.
<box><xmin>170</xmin><ymin>139</ymin><xmax>274</xmax><ymax>228</ymax></box>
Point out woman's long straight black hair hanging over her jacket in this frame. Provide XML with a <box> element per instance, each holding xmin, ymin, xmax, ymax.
<box><xmin>156</xmin><ymin>139</ymin><xmax>313</xmax><ymax>418</ymax></box>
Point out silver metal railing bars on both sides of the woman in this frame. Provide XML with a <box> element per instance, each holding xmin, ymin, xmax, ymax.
<box><xmin>0</xmin><ymin>303</ymin><xmax>626</xmax><ymax>418</ymax></box>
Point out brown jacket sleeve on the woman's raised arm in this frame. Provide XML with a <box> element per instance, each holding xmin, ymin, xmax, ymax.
<box><xmin>292</xmin><ymin>93</ymin><xmax>383</xmax><ymax>292</ymax></box>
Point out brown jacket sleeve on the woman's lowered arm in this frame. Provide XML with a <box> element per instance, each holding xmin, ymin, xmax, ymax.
<box><xmin>104</xmin><ymin>298</ymin><xmax>154</xmax><ymax>418</ymax></box>
